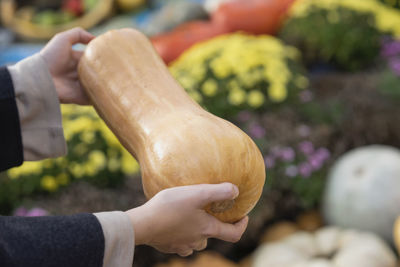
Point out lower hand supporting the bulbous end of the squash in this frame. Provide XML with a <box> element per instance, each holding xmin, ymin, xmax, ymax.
<box><xmin>127</xmin><ymin>183</ymin><xmax>248</xmax><ymax>256</ymax></box>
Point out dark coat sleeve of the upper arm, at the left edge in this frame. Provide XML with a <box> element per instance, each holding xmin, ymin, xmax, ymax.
<box><xmin>0</xmin><ymin>67</ymin><xmax>23</xmax><ymax>171</ymax></box>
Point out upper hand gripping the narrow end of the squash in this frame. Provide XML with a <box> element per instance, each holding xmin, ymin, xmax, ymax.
<box><xmin>40</xmin><ymin>28</ymin><xmax>94</xmax><ymax>105</ymax></box>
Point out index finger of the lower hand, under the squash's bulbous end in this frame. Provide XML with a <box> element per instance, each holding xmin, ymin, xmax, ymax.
<box><xmin>205</xmin><ymin>216</ymin><xmax>249</xmax><ymax>243</ymax></box>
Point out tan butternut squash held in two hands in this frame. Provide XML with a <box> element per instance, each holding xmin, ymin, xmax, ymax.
<box><xmin>79</xmin><ymin>29</ymin><xmax>265</xmax><ymax>222</ymax></box>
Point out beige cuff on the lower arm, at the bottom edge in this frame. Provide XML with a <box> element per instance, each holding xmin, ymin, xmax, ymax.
<box><xmin>94</xmin><ymin>211</ymin><xmax>135</xmax><ymax>267</ymax></box>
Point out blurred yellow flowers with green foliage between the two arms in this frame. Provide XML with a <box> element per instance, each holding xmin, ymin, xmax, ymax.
<box><xmin>0</xmin><ymin>105</ymin><xmax>139</xmax><ymax>216</ymax></box>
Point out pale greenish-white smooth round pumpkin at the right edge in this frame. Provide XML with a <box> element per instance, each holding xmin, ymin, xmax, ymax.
<box><xmin>323</xmin><ymin>145</ymin><xmax>400</xmax><ymax>242</ymax></box>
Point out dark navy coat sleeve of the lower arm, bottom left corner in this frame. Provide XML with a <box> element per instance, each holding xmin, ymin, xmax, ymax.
<box><xmin>0</xmin><ymin>214</ymin><xmax>104</xmax><ymax>267</ymax></box>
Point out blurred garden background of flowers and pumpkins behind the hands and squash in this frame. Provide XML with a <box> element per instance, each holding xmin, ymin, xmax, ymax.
<box><xmin>0</xmin><ymin>0</ymin><xmax>400</xmax><ymax>267</ymax></box>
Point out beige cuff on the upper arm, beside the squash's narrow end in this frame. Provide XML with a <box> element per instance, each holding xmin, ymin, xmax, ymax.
<box><xmin>8</xmin><ymin>54</ymin><xmax>67</xmax><ymax>160</ymax></box>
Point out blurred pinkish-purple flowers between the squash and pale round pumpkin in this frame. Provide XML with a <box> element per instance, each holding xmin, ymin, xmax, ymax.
<box><xmin>237</xmin><ymin>111</ymin><xmax>331</xmax><ymax>209</ymax></box>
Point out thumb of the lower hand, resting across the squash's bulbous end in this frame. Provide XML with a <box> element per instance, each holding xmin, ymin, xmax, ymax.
<box><xmin>192</xmin><ymin>183</ymin><xmax>239</xmax><ymax>208</ymax></box>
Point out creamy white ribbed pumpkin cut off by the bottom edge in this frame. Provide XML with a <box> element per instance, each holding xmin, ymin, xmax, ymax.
<box><xmin>252</xmin><ymin>227</ymin><xmax>397</xmax><ymax>267</ymax></box>
